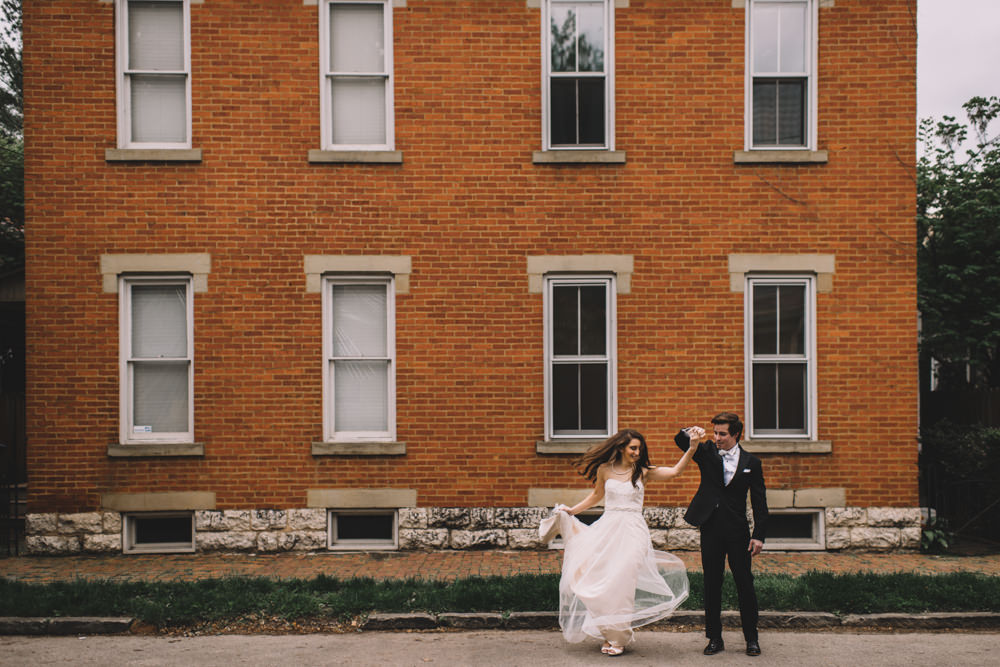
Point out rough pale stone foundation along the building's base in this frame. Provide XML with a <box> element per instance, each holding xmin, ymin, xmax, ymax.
<box><xmin>25</xmin><ymin>507</ymin><xmax>921</xmax><ymax>554</ymax></box>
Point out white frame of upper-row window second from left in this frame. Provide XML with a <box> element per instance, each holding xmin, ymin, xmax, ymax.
<box><xmin>317</xmin><ymin>0</ymin><xmax>396</xmax><ymax>151</ymax></box>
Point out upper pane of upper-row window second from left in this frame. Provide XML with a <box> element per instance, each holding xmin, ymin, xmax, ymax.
<box><xmin>330</xmin><ymin>3</ymin><xmax>385</xmax><ymax>73</ymax></box>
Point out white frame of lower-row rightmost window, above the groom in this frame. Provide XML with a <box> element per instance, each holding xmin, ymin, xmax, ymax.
<box><xmin>744</xmin><ymin>275</ymin><xmax>818</xmax><ymax>440</ymax></box>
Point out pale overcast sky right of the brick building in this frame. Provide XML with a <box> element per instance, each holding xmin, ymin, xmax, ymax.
<box><xmin>920</xmin><ymin>0</ymin><xmax>1000</xmax><ymax>121</ymax></box>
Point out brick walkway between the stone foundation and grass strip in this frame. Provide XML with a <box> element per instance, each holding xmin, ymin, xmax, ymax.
<box><xmin>0</xmin><ymin>551</ymin><xmax>1000</xmax><ymax>582</ymax></box>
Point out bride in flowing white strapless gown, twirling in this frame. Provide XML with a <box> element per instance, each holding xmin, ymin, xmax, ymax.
<box><xmin>539</xmin><ymin>426</ymin><xmax>705</xmax><ymax>656</ymax></box>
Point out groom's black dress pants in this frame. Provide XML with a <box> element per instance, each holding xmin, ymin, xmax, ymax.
<box><xmin>701</xmin><ymin>511</ymin><xmax>758</xmax><ymax>642</ymax></box>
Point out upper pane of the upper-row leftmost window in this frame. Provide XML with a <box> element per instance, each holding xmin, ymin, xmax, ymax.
<box><xmin>128</xmin><ymin>2</ymin><xmax>184</xmax><ymax>72</ymax></box>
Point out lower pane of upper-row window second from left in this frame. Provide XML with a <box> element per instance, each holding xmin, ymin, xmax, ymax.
<box><xmin>330</xmin><ymin>77</ymin><xmax>386</xmax><ymax>144</ymax></box>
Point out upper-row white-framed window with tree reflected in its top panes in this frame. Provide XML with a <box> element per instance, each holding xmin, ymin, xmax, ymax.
<box><xmin>542</xmin><ymin>0</ymin><xmax>614</xmax><ymax>150</ymax></box>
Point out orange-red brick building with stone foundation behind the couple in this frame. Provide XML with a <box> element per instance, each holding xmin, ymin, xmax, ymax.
<box><xmin>24</xmin><ymin>0</ymin><xmax>920</xmax><ymax>552</ymax></box>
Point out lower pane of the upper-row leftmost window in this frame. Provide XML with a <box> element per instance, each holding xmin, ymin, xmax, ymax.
<box><xmin>129</xmin><ymin>74</ymin><xmax>187</xmax><ymax>143</ymax></box>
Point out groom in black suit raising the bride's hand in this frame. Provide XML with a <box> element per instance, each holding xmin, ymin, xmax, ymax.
<box><xmin>674</xmin><ymin>412</ymin><xmax>767</xmax><ymax>656</ymax></box>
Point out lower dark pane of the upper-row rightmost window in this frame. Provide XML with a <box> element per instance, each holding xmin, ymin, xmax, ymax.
<box><xmin>753</xmin><ymin>79</ymin><xmax>806</xmax><ymax>146</ymax></box>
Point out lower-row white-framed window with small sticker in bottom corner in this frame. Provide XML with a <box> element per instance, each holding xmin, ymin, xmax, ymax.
<box><xmin>118</xmin><ymin>276</ymin><xmax>194</xmax><ymax>444</ymax></box>
